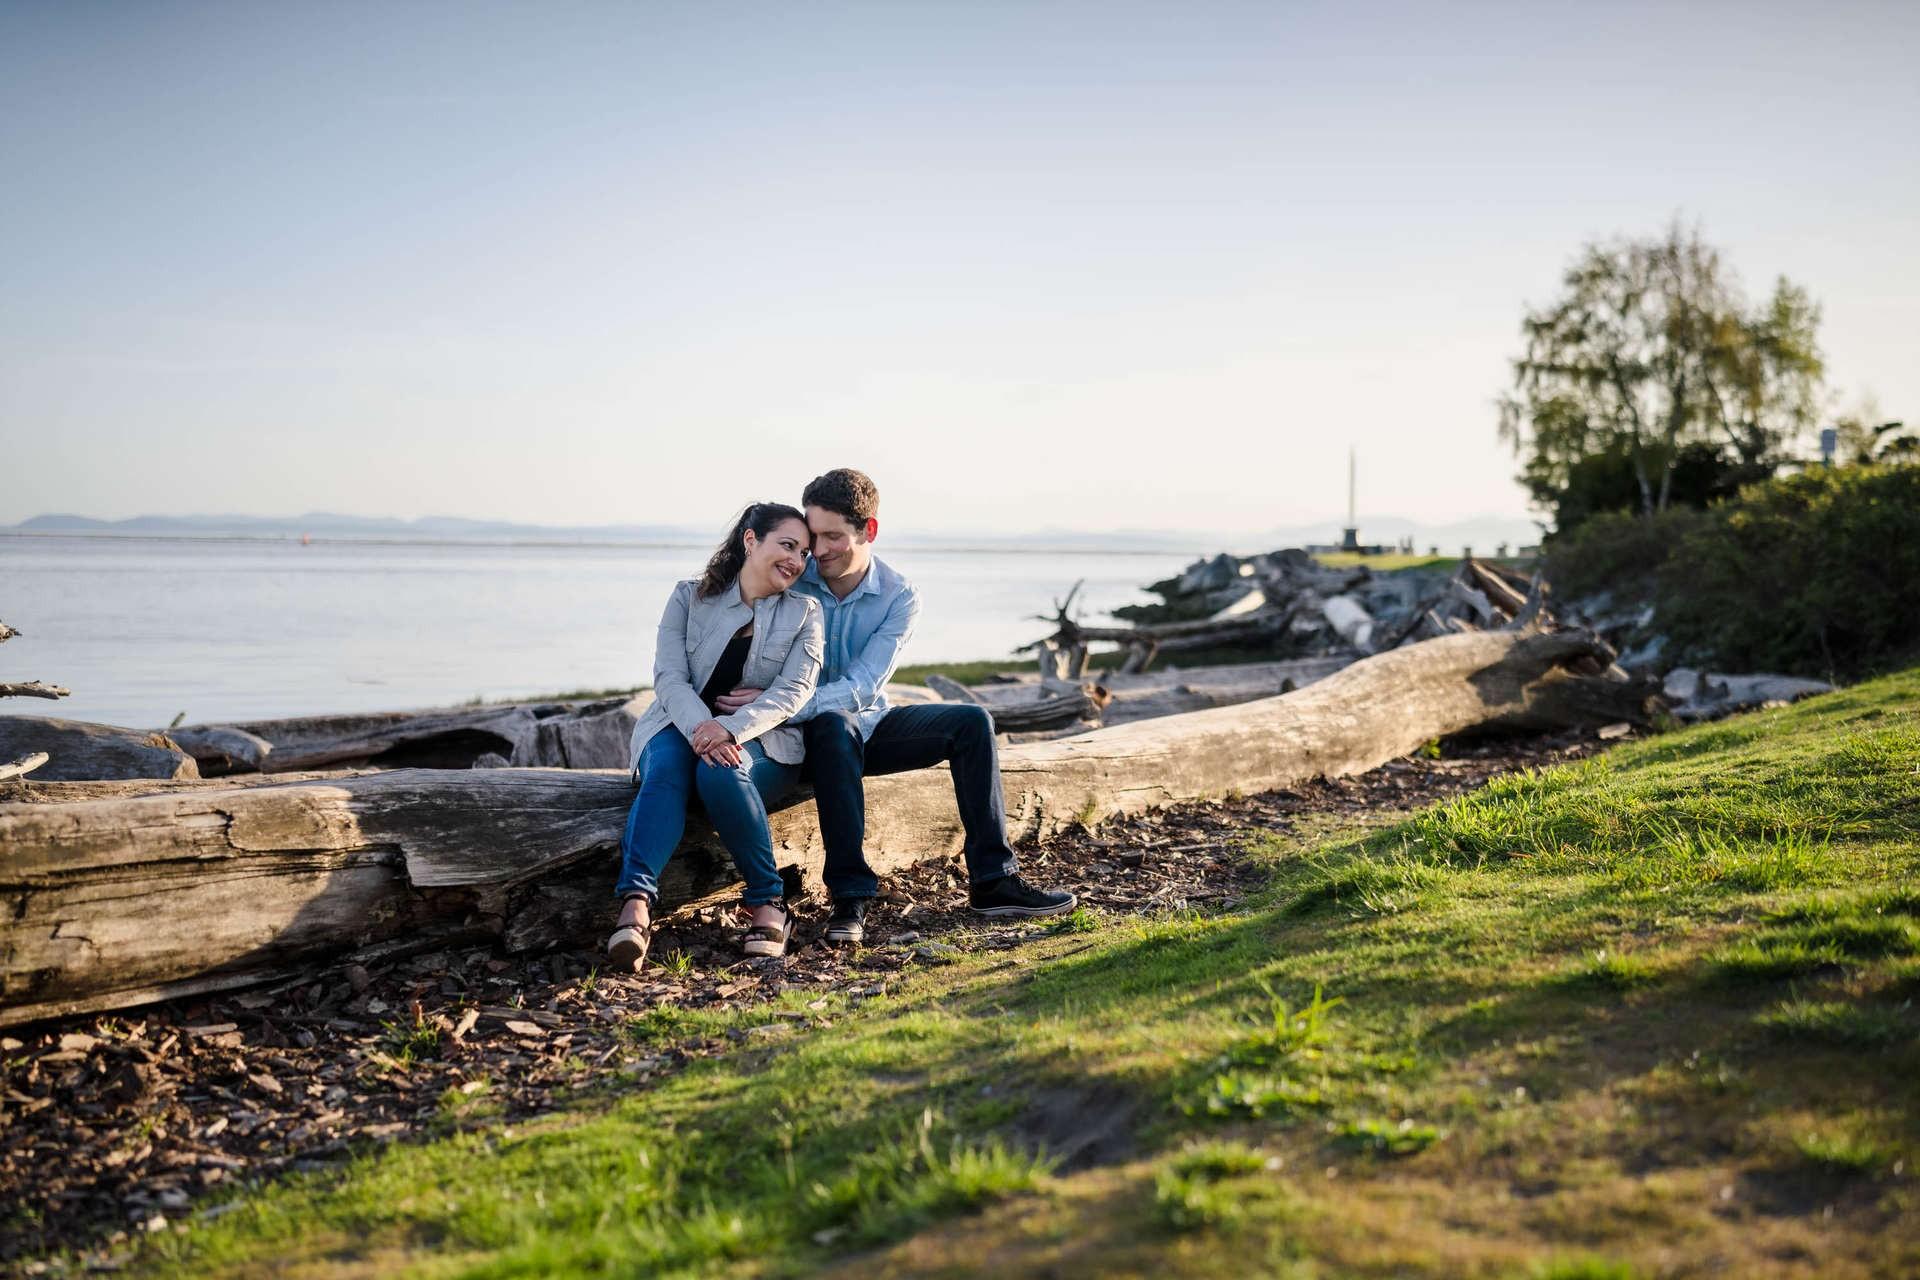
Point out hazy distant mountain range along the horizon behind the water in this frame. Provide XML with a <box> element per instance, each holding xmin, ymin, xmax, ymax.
<box><xmin>0</xmin><ymin>510</ymin><xmax>1540</xmax><ymax>555</ymax></box>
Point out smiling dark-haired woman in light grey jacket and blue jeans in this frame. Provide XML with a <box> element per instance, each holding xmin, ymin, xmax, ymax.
<box><xmin>607</xmin><ymin>503</ymin><xmax>826</xmax><ymax>969</ymax></box>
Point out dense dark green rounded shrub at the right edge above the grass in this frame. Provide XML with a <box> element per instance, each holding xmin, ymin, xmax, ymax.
<box><xmin>1655</xmin><ymin>466</ymin><xmax>1920</xmax><ymax>679</ymax></box>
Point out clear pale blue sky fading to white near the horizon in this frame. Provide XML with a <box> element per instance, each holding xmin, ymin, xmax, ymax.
<box><xmin>0</xmin><ymin>0</ymin><xmax>1920</xmax><ymax>530</ymax></box>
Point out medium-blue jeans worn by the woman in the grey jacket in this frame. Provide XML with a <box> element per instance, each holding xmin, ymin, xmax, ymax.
<box><xmin>614</xmin><ymin>725</ymin><xmax>801</xmax><ymax>906</ymax></box>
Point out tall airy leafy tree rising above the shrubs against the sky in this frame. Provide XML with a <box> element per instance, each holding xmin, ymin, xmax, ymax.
<box><xmin>1500</xmin><ymin>225</ymin><xmax>1822</xmax><ymax>532</ymax></box>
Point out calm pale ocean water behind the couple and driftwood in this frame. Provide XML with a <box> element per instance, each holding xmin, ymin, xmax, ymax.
<box><xmin>0</xmin><ymin>535</ymin><xmax>1192</xmax><ymax>727</ymax></box>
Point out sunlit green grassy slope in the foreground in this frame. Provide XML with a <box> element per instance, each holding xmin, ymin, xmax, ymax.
<box><xmin>127</xmin><ymin>670</ymin><xmax>1920</xmax><ymax>1276</ymax></box>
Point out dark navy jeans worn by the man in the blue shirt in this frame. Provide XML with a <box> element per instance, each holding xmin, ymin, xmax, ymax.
<box><xmin>803</xmin><ymin>702</ymin><xmax>1020</xmax><ymax>902</ymax></box>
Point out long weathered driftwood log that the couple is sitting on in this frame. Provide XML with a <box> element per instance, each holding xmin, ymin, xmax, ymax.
<box><xmin>0</xmin><ymin>631</ymin><xmax>1634</xmax><ymax>1025</ymax></box>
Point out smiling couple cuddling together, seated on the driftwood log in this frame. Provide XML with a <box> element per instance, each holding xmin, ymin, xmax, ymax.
<box><xmin>607</xmin><ymin>468</ymin><xmax>1075</xmax><ymax>969</ymax></box>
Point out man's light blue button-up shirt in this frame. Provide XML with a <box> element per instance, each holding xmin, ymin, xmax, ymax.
<box><xmin>793</xmin><ymin>557</ymin><xmax>920</xmax><ymax>741</ymax></box>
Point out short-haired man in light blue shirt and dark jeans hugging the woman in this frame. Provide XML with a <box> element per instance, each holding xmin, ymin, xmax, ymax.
<box><xmin>718</xmin><ymin>468</ymin><xmax>1075</xmax><ymax>942</ymax></box>
